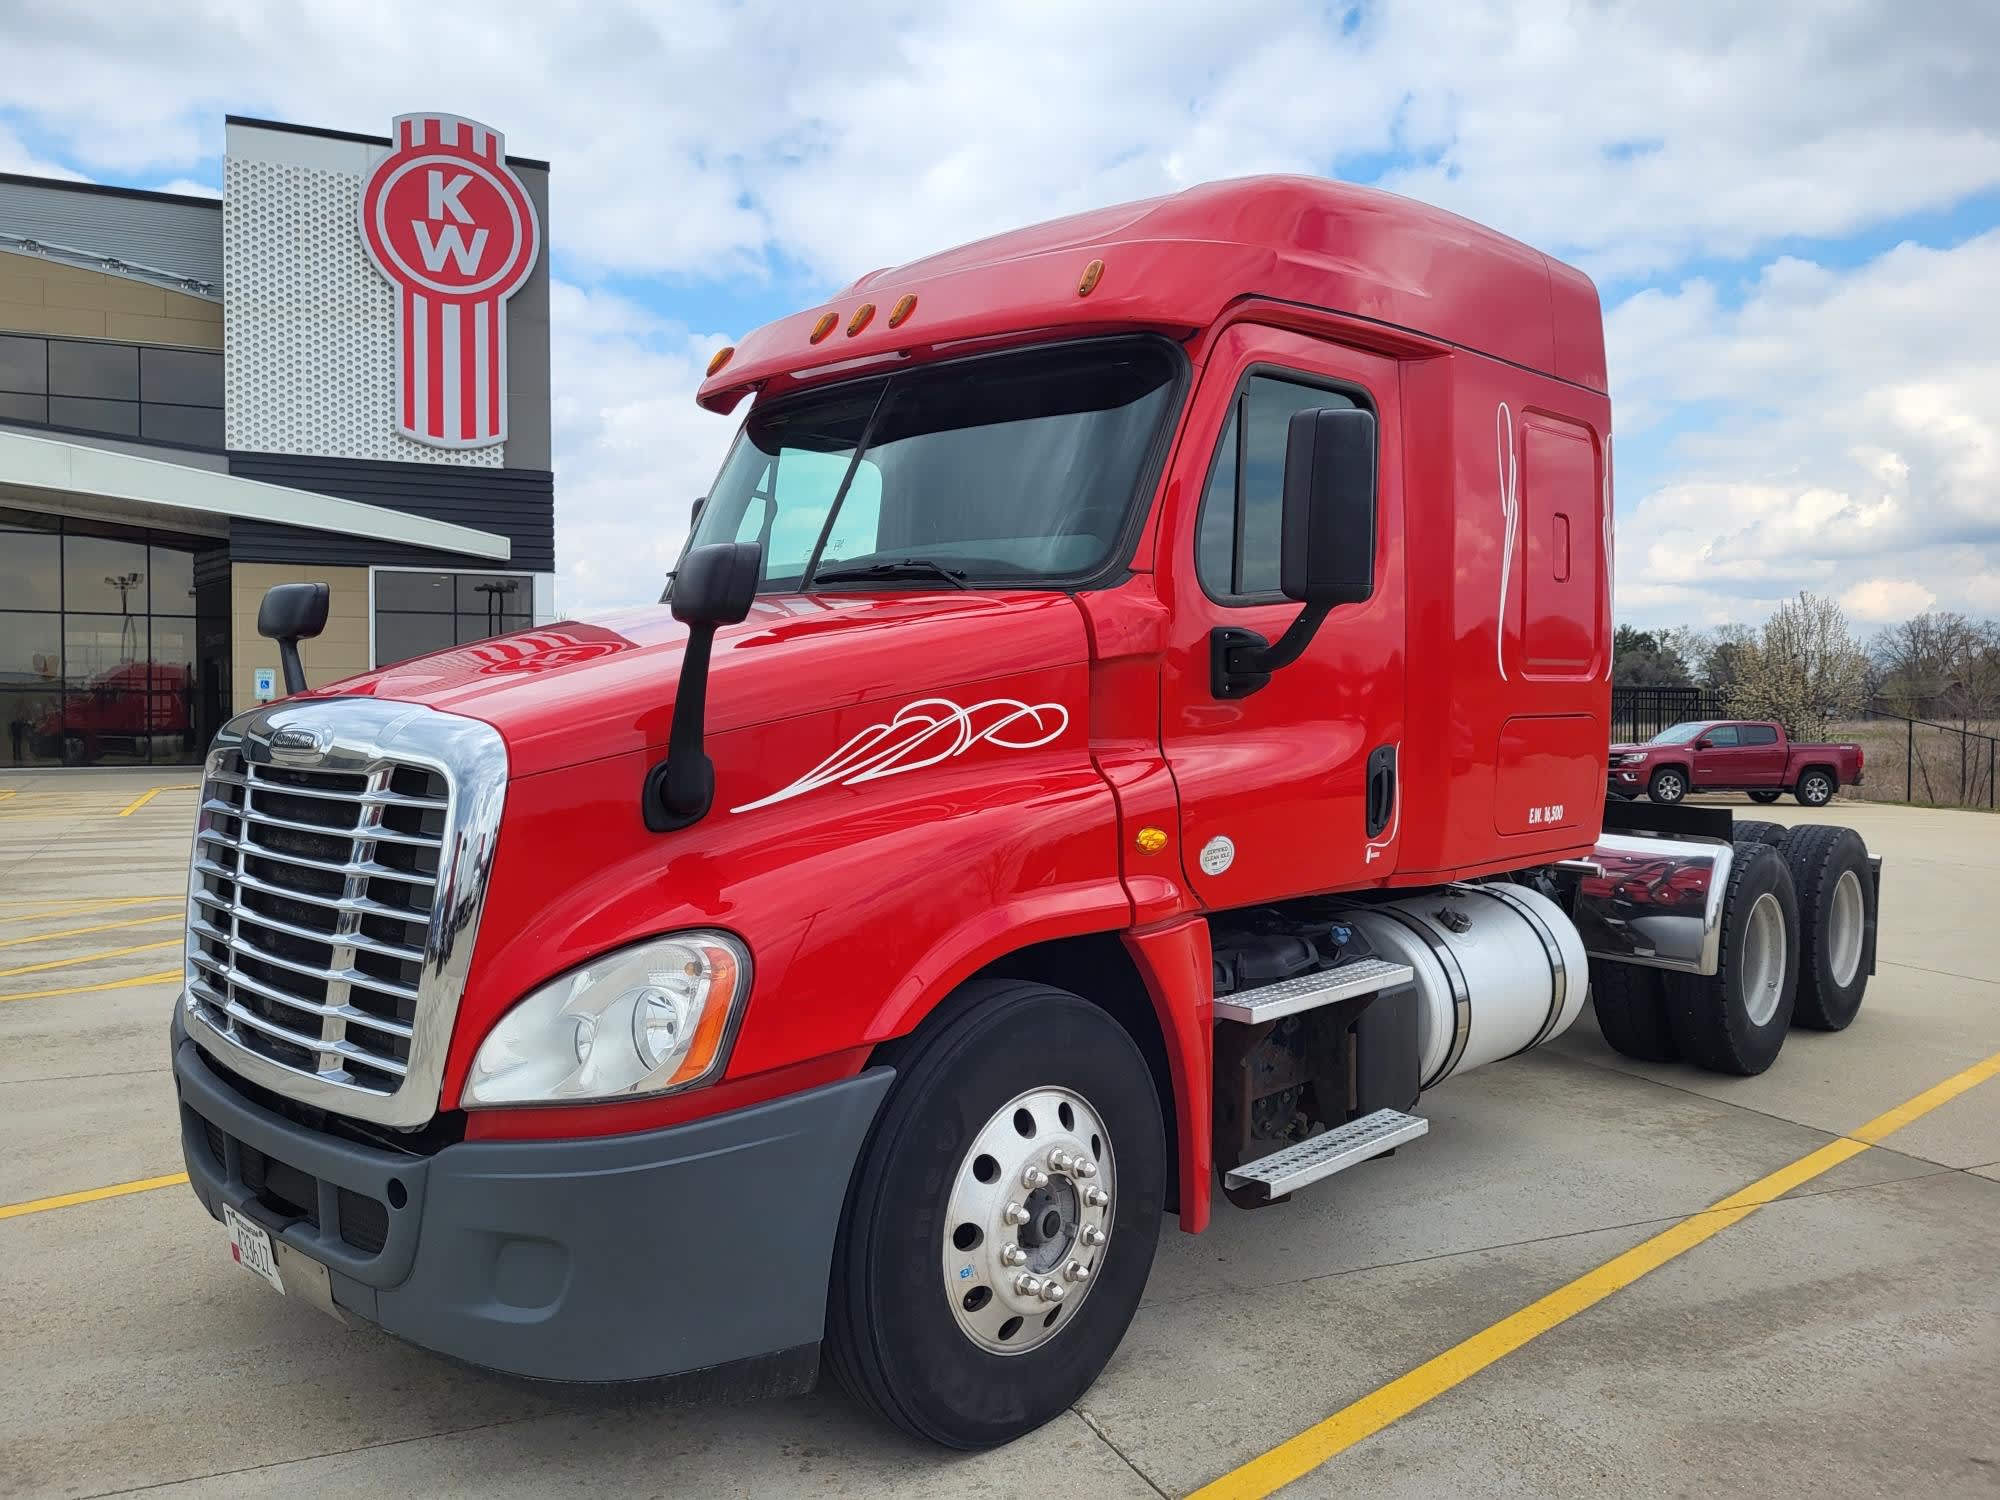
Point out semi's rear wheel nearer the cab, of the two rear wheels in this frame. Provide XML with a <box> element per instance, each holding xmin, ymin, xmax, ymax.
<box><xmin>1666</xmin><ymin>838</ymin><xmax>1798</xmax><ymax>1076</ymax></box>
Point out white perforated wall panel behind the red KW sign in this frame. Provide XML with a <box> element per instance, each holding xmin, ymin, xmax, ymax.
<box><xmin>222</xmin><ymin>126</ymin><xmax>506</xmax><ymax>468</ymax></box>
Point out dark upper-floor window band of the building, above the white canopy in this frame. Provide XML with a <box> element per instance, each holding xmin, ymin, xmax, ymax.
<box><xmin>0</xmin><ymin>334</ymin><xmax>222</xmax><ymax>448</ymax></box>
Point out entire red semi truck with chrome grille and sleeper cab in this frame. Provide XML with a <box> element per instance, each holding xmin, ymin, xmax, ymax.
<box><xmin>174</xmin><ymin>178</ymin><xmax>1878</xmax><ymax>1448</ymax></box>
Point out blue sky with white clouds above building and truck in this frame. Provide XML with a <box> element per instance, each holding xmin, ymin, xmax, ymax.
<box><xmin>0</xmin><ymin>0</ymin><xmax>2000</xmax><ymax>626</ymax></box>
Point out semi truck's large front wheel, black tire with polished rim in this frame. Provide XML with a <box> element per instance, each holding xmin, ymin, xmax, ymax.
<box><xmin>828</xmin><ymin>980</ymin><xmax>1166</xmax><ymax>1448</ymax></box>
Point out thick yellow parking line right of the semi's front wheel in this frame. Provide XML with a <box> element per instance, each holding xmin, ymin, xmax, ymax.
<box><xmin>1190</xmin><ymin>1052</ymin><xmax>2000</xmax><ymax>1500</ymax></box>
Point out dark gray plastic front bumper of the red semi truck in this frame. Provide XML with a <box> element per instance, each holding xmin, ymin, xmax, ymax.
<box><xmin>174</xmin><ymin>1016</ymin><xmax>894</xmax><ymax>1380</ymax></box>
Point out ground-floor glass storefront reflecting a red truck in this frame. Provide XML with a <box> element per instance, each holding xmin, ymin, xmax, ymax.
<box><xmin>0</xmin><ymin>508</ymin><xmax>230</xmax><ymax>766</ymax></box>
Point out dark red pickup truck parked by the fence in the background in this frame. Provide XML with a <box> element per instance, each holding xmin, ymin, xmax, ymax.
<box><xmin>1606</xmin><ymin>718</ymin><xmax>1862</xmax><ymax>808</ymax></box>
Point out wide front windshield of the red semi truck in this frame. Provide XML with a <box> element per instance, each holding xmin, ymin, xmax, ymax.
<box><xmin>690</xmin><ymin>338</ymin><xmax>1178</xmax><ymax>592</ymax></box>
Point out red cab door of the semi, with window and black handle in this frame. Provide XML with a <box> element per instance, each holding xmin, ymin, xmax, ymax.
<box><xmin>1158</xmin><ymin>324</ymin><xmax>1408</xmax><ymax>908</ymax></box>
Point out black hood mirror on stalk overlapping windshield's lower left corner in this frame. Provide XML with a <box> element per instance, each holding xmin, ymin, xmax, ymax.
<box><xmin>640</xmin><ymin>542</ymin><xmax>764</xmax><ymax>834</ymax></box>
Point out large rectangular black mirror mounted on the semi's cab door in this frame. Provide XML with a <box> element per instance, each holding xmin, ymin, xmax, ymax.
<box><xmin>1208</xmin><ymin>406</ymin><xmax>1376</xmax><ymax>698</ymax></box>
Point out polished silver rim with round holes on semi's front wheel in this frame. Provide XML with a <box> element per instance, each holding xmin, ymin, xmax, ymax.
<box><xmin>944</xmin><ymin>1088</ymin><xmax>1118</xmax><ymax>1354</ymax></box>
